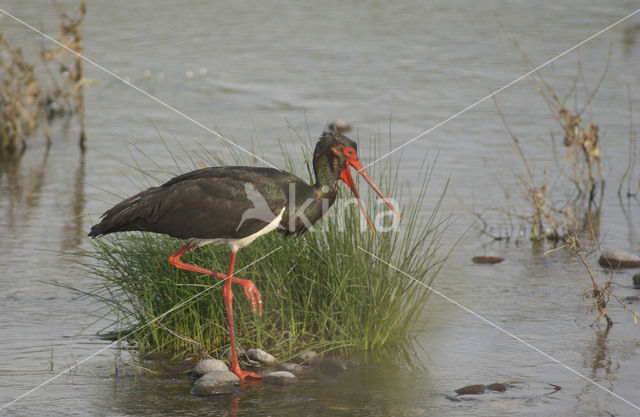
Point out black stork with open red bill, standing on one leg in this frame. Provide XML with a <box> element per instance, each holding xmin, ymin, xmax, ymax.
<box><xmin>89</xmin><ymin>130</ymin><xmax>400</xmax><ymax>382</ymax></box>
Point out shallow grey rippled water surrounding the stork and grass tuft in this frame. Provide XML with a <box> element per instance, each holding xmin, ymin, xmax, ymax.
<box><xmin>0</xmin><ymin>0</ymin><xmax>640</xmax><ymax>416</ymax></box>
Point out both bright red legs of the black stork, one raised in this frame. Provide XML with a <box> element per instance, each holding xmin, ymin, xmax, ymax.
<box><xmin>169</xmin><ymin>243</ymin><xmax>262</xmax><ymax>382</ymax></box>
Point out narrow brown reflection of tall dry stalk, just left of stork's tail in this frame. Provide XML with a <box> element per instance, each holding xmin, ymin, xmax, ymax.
<box><xmin>60</xmin><ymin>152</ymin><xmax>86</xmax><ymax>250</ymax></box>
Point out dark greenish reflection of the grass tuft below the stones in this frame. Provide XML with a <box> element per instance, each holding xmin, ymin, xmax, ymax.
<box><xmin>102</xmin><ymin>360</ymin><xmax>432</xmax><ymax>417</ymax></box>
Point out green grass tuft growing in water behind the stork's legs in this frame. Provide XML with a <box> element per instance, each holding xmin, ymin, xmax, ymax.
<box><xmin>81</xmin><ymin>138</ymin><xmax>447</xmax><ymax>359</ymax></box>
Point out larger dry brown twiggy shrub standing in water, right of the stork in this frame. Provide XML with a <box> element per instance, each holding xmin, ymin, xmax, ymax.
<box><xmin>473</xmin><ymin>53</ymin><xmax>608</xmax><ymax>243</ymax></box>
